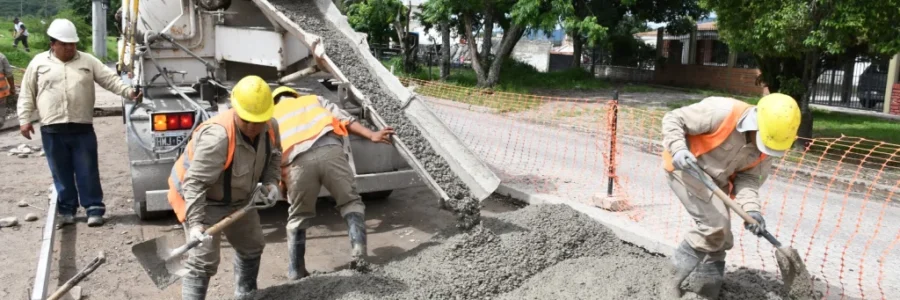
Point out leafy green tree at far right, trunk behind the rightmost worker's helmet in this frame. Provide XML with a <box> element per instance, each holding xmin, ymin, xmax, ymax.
<box><xmin>700</xmin><ymin>0</ymin><xmax>900</xmax><ymax>138</ymax></box>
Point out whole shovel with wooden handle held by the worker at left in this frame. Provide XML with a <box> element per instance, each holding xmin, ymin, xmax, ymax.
<box><xmin>131</xmin><ymin>186</ymin><xmax>276</xmax><ymax>289</ymax></box>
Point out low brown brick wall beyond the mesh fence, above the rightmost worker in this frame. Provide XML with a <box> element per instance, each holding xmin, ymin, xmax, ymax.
<box><xmin>654</xmin><ymin>64</ymin><xmax>765</xmax><ymax>96</ymax></box>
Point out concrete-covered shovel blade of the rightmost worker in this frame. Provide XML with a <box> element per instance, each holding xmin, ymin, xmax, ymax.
<box><xmin>775</xmin><ymin>247</ymin><xmax>815</xmax><ymax>299</ymax></box>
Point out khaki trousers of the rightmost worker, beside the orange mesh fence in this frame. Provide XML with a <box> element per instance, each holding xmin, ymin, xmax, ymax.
<box><xmin>668</xmin><ymin>170</ymin><xmax>734</xmax><ymax>262</ymax></box>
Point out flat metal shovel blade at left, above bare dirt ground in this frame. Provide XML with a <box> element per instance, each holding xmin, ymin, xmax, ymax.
<box><xmin>131</xmin><ymin>236</ymin><xmax>187</xmax><ymax>290</ymax></box>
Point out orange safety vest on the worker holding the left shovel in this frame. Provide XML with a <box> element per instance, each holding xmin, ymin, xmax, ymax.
<box><xmin>168</xmin><ymin>109</ymin><xmax>275</xmax><ymax>222</ymax></box>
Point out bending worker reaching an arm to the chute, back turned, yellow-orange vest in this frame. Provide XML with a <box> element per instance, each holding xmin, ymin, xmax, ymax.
<box><xmin>274</xmin><ymin>87</ymin><xmax>394</xmax><ymax>280</ymax></box>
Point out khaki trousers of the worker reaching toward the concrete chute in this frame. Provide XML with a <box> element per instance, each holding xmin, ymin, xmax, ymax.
<box><xmin>282</xmin><ymin>145</ymin><xmax>366</xmax><ymax>232</ymax></box>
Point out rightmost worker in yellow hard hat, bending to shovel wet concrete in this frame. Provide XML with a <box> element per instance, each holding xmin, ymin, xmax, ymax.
<box><xmin>662</xmin><ymin>93</ymin><xmax>800</xmax><ymax>299</ymax></box>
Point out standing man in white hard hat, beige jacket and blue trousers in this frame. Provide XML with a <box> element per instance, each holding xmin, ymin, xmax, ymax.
<box><xmin>18</xmin><ymin>19</ymin><xmax>141</xmax><ymax>226</ymax></box>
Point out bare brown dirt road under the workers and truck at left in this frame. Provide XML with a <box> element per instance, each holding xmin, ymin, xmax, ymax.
<box><xmin>0</xmin><ymin>117</ymin><xmax>515</xmax><ymax>299</ymax></box>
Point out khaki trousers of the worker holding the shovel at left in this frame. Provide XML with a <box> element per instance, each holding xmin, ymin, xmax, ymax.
<box><xmin>184</xmin><ymin>205</ymin><xmax>266</xmax><ymax>277</ymax></box>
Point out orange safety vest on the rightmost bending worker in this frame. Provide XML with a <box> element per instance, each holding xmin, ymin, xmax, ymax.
<box><xmin>662</xmin><ymin>99</ymin><xmax>767</xmax><ymax>199</ymax></box>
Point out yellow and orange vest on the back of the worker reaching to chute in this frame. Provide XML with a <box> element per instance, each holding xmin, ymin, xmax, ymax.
<box><xmin>273</xmin><ymin>95</ymin><xmax>347</xmax><ymax>153</ymax></box>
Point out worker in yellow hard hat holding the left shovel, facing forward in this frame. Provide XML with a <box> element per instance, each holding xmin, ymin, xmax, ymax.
<box><xmin>168</xmin><ymin>76</ymin><xmax>281</xmax><ymax>300</ymax></box>
